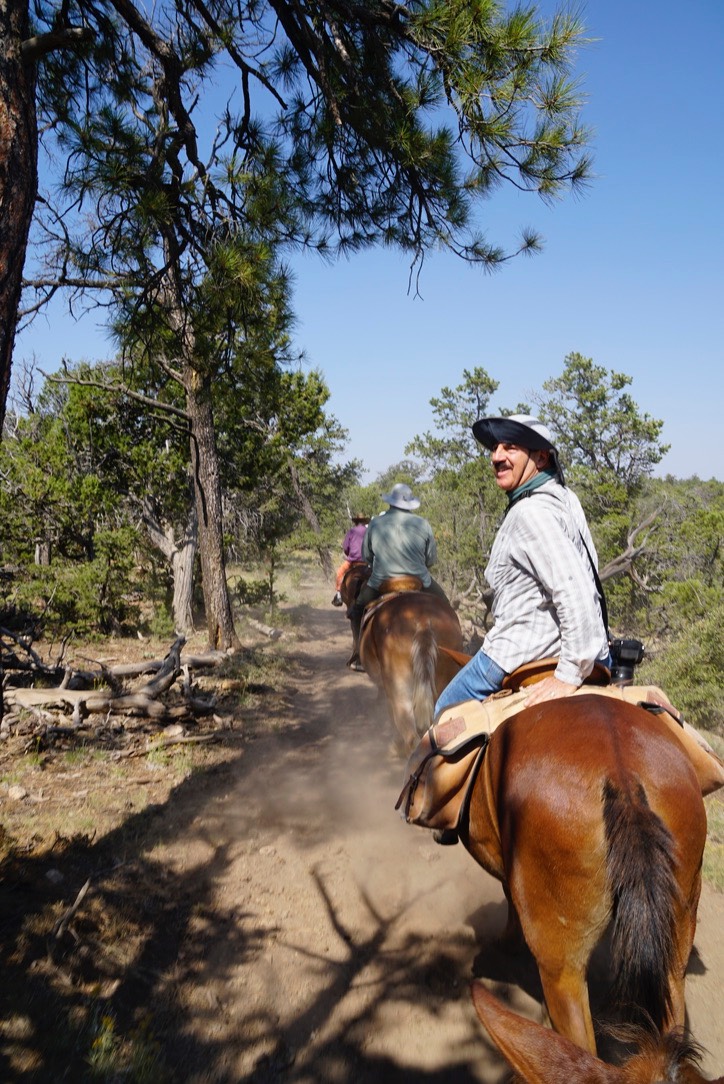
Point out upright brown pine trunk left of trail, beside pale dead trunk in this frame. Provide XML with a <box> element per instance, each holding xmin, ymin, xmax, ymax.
<box><xmin>186</xmin><ymin>370</ymin><xmax>241</xmax><ymax>650</ymax></box>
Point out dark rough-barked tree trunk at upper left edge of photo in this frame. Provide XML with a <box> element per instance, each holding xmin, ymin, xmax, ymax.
<box><xmin>0</xmin><ymin>0</ymin><xmax>38</xmax><ymax>433</ymax></box>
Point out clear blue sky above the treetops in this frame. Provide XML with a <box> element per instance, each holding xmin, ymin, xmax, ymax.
<box><xmin>15</xmin><ymin>0</ymin><xmax>724</xmax><ymax>481</ymax></box>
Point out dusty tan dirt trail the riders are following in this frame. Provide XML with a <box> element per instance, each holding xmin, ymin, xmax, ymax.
<box><xmin>153</xmin><ymin>608</ymin><xmax>724</xmax><ymax>1084</ymax></box>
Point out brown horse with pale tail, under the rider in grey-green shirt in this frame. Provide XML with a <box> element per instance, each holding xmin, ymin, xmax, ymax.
<box><xmin>360</xmin><ymin>591</ymin><xmax>463</xmax><ymax>754</ymax></box>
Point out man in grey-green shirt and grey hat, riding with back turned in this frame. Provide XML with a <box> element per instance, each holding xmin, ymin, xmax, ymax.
<box><xmin>349</xmin><ymin>482</ymin><xmax>448</xmax><ymax>670</ymax></box>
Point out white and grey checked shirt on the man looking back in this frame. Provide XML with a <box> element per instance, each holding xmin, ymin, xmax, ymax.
<box><xmin>482</xmin><ymin>480</ymin><xmax>608</xmax><ymax>685</ymax></box>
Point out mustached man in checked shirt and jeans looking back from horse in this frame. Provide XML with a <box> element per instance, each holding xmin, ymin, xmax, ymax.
<box><xmin>435</xmin><ymin>414</ymin><xmax>610</xmax><ymax>714</ymax></box>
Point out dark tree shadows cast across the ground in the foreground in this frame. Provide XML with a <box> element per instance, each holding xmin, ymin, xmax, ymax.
<box><xmin>0</xmin><ymin>745</ymin><xmax>502</xmax><ymax>1084</ymax></box>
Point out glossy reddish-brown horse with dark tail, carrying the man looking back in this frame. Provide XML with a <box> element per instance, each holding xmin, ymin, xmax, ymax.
<box><xmin>460</xmin><ymin>695</ymin><xmax>707</xmax><ymax>1057</ymax></box>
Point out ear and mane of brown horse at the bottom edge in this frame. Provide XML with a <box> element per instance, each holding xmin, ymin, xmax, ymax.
<box><xmin>471</xmin><ymin>982</ymin><xmax>724</xmax><ymax>1084</ymax></box>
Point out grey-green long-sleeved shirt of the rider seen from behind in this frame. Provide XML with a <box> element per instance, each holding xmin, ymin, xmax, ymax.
<box><xmin>362</xmin><ymin>507</ymin><xmax>438</xmax><ymax>588</ymax></box>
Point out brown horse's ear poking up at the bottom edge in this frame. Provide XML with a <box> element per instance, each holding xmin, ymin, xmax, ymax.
<box><xmin>470</xmin><ymin>982</ymin><xmax>625</xmax><ymax>1084</ymax></box>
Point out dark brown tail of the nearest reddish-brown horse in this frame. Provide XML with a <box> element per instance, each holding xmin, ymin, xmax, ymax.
<box><xmin>604</xmin><ymin>780</ymin><xmax>680</xmax><ymax>1030</ymax></box>
